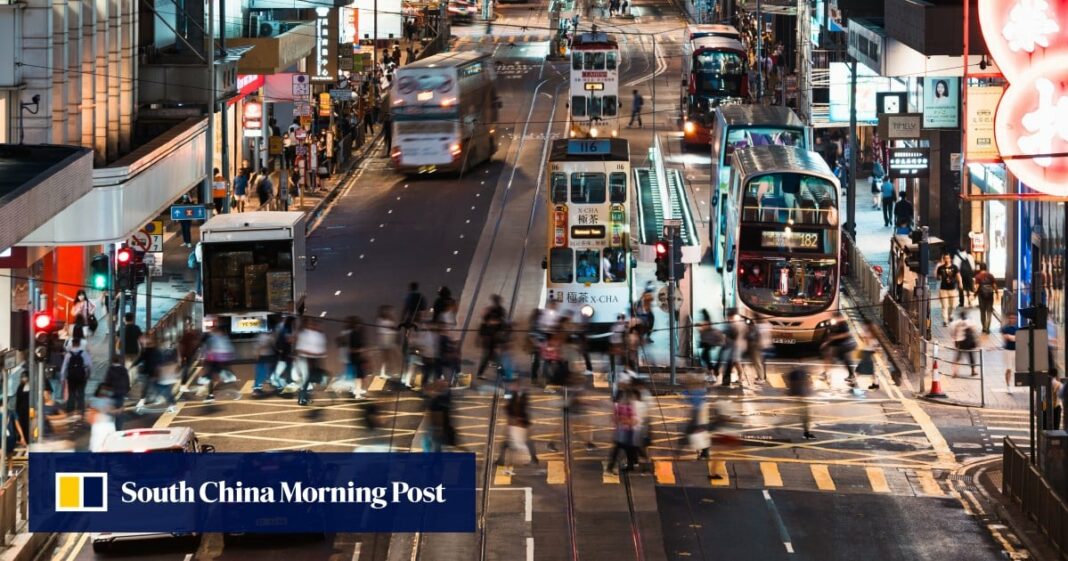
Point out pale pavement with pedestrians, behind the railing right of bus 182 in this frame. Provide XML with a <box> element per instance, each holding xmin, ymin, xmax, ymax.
<box><xmin>841</xmin><ymin>177</ymin><xmax>1027</xmax><ymax>409</ymax></box>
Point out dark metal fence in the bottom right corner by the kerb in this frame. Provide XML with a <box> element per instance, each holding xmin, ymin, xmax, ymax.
<box><xmin>1002</xmin><ymin>436</ymin><xmax>1068</xmax><ymax>559</ymax></box>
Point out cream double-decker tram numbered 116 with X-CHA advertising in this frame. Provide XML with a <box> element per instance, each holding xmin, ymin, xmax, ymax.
<box><xmin>545</xmin><ymin>138</ymin><xmax>631</xmax><ymax>327</ymax></box>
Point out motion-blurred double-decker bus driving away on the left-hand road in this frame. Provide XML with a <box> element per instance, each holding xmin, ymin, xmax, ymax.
<box><xmin>390</xmin><ymin>51</ymin><xmax>501</xmax><ymax>173</ymax></box>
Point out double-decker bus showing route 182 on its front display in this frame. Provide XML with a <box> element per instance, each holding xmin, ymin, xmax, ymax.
<box><xmin>723</xmin><ymin>145</ymin><xmax>841</xmax><ymax>344</ymax></box>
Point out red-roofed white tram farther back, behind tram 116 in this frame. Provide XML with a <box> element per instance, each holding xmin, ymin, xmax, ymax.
<box><xmin>569</xmin><ymin>32</ymin><xmax>621</xmax><ymax>138</ymax></box>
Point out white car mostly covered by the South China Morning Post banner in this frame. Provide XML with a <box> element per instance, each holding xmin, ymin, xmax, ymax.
<box><xmin>90</xmin><ymin>426</ymin><xmax>215</xmax><ymax>554</ymax></box>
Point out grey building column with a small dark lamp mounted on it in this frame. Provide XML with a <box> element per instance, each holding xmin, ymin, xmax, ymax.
<box><xmin>20</xmin><ymin>0</ymin><xmax>53</xmax><ymax>144</ymax></box>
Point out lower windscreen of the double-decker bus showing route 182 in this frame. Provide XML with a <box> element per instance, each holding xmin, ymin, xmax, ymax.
<box><xmin>738</xmin><ymin>255</ymin><xmax>838</xmax><ymax>315</ymax></box>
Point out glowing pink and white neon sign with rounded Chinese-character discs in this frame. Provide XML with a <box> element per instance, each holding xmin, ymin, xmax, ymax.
<box><xmin>978</xmin><ymin>0</ymin><xmax>1068</xmax><ymax>197</ymax></box>
